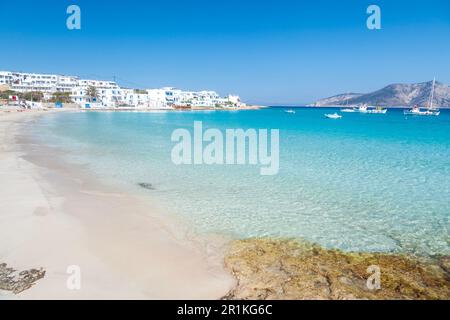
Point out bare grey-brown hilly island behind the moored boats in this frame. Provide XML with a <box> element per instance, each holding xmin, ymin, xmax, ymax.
<box><xmin>308</xmin><ymin>81</ymin><xmax>450</xmax><ymax>108</ymax></box>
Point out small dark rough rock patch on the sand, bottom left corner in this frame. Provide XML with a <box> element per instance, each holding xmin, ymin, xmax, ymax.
<box><xmin>0</xmin><ymin>263</ymin><xmax>45</xmax><ymax>294</ymax></box>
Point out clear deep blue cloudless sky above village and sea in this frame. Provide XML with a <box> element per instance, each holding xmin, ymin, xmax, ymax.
<box><xmin>0</xmin><ymin>0</ymin><xmax>450</xmax><ymax>104</ymax></box>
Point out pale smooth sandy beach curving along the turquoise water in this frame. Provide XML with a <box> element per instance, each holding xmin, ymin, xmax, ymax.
<box><xmin>0</xmin><ymin>112</ymin><xmax>234</xmax><ymax>299</ymax></box>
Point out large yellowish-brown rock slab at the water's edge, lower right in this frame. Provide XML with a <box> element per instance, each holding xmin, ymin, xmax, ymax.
<box><xmin>223</xmin><ymin>239</ymin><xmax>450</xmax><ymax>299</ymax></box>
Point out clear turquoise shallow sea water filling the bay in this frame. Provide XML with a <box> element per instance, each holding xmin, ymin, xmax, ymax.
<box><xmin>32</xmin><ymin>108</ymin><xmax>450</xmax><ymax>255</ymax></box>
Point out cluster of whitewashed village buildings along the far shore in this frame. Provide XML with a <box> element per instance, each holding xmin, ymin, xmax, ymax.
<box><xmin>0</xmin><ymin>71</ymin><xmax>244</xmax><ymax>109</ymax></box>
